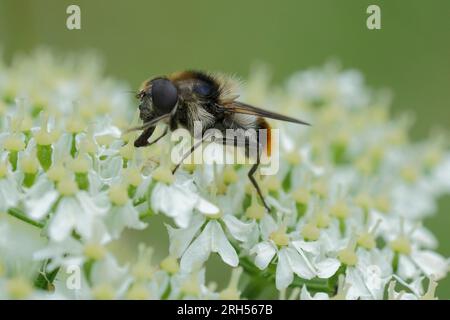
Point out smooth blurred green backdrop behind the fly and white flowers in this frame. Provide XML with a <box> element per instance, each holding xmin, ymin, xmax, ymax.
<box><xmin>0</xmin><ymin>0</ymin><xmax>450</xmax><ymax>298</ymax></box>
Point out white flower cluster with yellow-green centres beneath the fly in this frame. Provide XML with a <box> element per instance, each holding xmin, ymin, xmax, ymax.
<box><xmin>0</xmin><ymin>50</ymin><xmax>450</xmax><ymax>299</ymax></box>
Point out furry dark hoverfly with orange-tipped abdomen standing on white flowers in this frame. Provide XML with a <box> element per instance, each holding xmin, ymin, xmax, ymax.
<box><xmin>129</xmin><ymin>71</ymin><xmax>309</xmax><ymax>211</ymax></box>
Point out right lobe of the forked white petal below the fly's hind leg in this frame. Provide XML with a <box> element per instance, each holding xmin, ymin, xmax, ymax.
<box><xmin>210</xmin><ymin>220</ymin><xmax>239</xmax><ymax>267</ymax></box>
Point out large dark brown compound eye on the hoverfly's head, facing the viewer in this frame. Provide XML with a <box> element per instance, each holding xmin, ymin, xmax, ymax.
<box><xmin>152</xmin><ymin>78</ymin><xmax>178</xmax><ymax>114</ymax></box>
